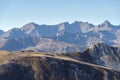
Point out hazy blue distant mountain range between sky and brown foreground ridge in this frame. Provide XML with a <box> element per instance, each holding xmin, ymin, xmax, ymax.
<box><xmin>0</xmin><ymin>20</ymin><xmax>120</xmax><ymax>52</ymax></box>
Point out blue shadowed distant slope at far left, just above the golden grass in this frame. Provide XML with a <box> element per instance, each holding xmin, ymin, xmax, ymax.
<box><xmin>1</xmin><ymin>37</ymin><xmax>39</xmax><ymax>51</ymax></box>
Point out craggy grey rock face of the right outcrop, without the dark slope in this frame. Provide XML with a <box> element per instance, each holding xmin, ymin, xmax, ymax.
<box><xmin>86</xmin><ymin>43</ymin><xmax>120</xmax><ymax>70</ymax></box>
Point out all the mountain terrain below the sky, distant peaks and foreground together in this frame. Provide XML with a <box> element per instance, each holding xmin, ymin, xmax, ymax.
<box><xmin>0</xmin><ymin>21</ymin><xmax>120</xmax><ymax>80</ymax></box>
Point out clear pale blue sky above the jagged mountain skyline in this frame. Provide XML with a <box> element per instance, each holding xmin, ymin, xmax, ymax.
<box><xmin>0</xmin><ymin>0</ymin><xmax>120</xmax><ymax>30</ymax></box>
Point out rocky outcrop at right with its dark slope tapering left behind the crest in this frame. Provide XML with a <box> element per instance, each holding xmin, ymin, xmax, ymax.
<box><xmin>60</xmin><ymin>43</ymin><xmax>120</xmax><ymax>70</ymax></box>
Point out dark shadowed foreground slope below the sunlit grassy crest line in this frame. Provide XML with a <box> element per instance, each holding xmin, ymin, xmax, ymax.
<box><xmin>0</xmin><ymin>57</ymin><xmax>120</xmax><ymax>80</ymax></box>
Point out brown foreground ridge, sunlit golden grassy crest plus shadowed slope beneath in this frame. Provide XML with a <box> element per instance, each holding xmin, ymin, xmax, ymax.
<box><xmin>0</xmin><ymin>48</ymin><xmax>120</xmax><ymax>80</ymax></box>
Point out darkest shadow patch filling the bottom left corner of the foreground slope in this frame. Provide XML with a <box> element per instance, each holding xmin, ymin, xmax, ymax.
<box><xmin>0</xmin><ymin>63</ymin><xmax>35</xmax><ymax>80</ymax></box>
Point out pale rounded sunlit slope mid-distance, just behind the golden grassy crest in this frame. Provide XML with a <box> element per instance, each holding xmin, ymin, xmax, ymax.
<box><xmin>24</xmin><ymin>38</ymin><xmax>86</xmax><ymax>53</ymax></box>
